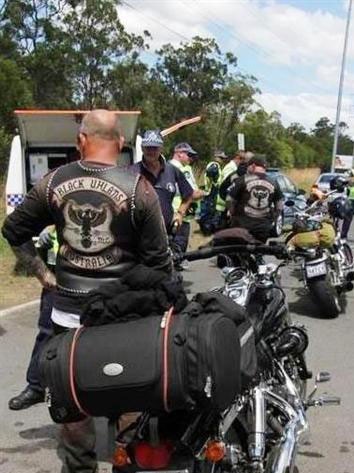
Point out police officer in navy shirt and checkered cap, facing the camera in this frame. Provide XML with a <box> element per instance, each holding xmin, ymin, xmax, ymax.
<box><xmin>133</xmin><ymin>130</ymin><xmax>193</xmax><ymax>233</ymax></box>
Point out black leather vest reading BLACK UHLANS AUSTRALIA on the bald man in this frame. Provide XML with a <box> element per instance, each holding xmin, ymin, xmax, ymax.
<box><xmin>47</xmin><ymin>161</ymin><xmax>139</xmax><ymax>295</ymax></box>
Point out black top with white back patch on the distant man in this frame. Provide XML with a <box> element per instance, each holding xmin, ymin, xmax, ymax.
<box><xmin>228</xmin><ymin>173</ymin><xmax>283</xmax><ymax>232</ymax></box>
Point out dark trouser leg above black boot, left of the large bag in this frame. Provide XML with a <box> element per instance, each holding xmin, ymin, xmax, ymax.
<box><xmin>26</xmin><ymin>289</ymin><xmax>53</xmax><ymax>392</ymax></box>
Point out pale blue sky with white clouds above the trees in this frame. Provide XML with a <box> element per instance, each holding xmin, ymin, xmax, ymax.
<box><xmin>119</xmin><ymin>0</ymin><xmax>354</xmax><ymax>137</ymax></box>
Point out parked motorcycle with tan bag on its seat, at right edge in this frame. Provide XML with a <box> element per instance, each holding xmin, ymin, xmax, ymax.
<box><xmin>285</xmin><ymin>191</ymin><xmax>354</xmax><ymax>318</ymax></box>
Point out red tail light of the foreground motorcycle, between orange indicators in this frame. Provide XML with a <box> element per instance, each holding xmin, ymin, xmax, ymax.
<box><xmin>134</xmin><ymin>442</ymin><xmax>173</xmax><ymax>470</ymax></box>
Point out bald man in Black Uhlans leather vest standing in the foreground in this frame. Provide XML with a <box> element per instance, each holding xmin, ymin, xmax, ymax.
<box><xmin>2</xmin><ymin>110</ymin><xmax>172</xmax><ymax>473</ymax></box>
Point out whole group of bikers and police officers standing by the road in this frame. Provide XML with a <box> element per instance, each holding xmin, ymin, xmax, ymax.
<box><xmin>2</xmin><ymin>110</ymin><xmax>282</xmax><ymax>473</ymax></box>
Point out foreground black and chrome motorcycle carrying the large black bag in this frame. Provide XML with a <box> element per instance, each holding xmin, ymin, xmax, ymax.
<box><xmin>113</xmin><ymin>240</ymin><xmax>340</xmax><ymax>473</ymax></box>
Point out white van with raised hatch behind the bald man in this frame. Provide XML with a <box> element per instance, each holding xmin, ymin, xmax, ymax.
<box><xmin>6</xmin><ymin>110</ymin><xmax>141</xmax><ymax>214</ymax></box>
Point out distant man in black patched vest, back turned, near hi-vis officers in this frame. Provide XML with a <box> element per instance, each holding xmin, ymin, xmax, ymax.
<box><xmin>227</xmin><ymin>156</ymin><xmax>283</xmax><ymax>242</ymax></box>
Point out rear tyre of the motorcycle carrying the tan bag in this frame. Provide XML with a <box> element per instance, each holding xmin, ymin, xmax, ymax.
<box><xmin>307</xmin><ymin>279</ymin><xmax>342</xmax><ymax>319</ymax></box>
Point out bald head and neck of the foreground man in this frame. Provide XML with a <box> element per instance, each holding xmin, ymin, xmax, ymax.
<box><xmin>78</xmin><ymin>109</ymin><xmax>124</xmax><ymax>164</ymax></box>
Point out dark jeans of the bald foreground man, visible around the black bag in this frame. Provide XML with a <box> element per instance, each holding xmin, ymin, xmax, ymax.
<box><xmin>53</xmin><ymin>324</ymin><xmax>97</xmax><ymax>473</ymax></box>
